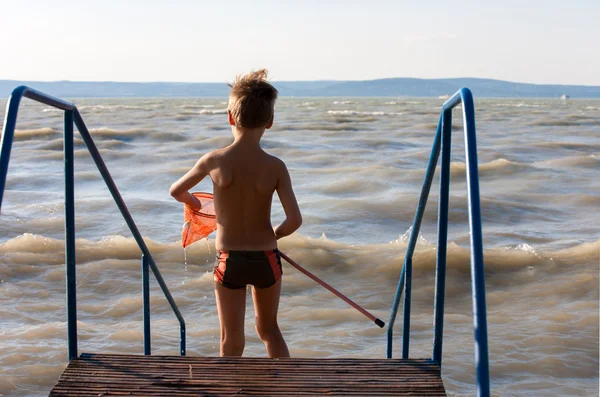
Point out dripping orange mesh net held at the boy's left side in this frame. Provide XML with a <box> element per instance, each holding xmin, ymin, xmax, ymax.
<box><xmin>181</xmin><ymin>192</ymin><xmax>217</xmax><ymax>248</ymax></box>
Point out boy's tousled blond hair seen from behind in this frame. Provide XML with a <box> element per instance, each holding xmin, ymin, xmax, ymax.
<box><xmin>228</xmin><ymin>69</ymin><xmax>277</xmax><ymax>128</ymax></box>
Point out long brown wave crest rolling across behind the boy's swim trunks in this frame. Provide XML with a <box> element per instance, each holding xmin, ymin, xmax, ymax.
<box><xmin>0</xmin><ymin>229</ymin><xmax>600</xmax><ymax>281</ymax></box>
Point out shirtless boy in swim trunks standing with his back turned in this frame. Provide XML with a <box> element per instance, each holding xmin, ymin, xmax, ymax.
<box><xmin>170</xmin><ymin>69</ymin><xmax>302</xmax><ymax>358</ymax></box>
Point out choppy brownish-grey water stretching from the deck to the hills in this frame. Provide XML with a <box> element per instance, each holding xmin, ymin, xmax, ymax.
<box><xmin>0</xmin><ymin>94</ymin><xmax>600</xmax><ymax>396</ymax></box>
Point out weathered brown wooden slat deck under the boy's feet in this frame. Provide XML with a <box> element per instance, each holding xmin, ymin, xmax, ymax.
<box><xmin>50</xmin><ymin>354</ymin><xmax>446</xmax><ymax>397</ymax></box>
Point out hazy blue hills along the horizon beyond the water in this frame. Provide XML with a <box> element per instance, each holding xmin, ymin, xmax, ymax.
<box><xmin>0</xmin><ymin>78</ymin><xmax>600</xmax><ymax>98</ymax></box>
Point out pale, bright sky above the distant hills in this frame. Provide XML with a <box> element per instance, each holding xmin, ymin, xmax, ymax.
<box><xmin>0</xmin><ymin>0</ymin><xmax>600</xmax><ymax>85</ymax></box>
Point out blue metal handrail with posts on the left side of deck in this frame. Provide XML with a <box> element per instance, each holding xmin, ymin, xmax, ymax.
<box><xmin>0</xmin><ymin>86</ymin><xmax>186</xmax><ymax>360</ymax></box>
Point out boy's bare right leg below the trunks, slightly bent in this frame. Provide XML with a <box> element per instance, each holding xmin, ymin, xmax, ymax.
<box><xmin>252</xmin><ymin>279</ymin><xmax>290</xmax><ymax>358</ymax></box>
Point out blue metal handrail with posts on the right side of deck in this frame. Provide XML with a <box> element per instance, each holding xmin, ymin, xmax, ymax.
<box><xmin>387</xmin><ymin>88</ymin><xmax>490</xmax><ymax>397</ymax></box>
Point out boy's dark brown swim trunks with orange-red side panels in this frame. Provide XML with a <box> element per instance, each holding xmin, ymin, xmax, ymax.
<box><xmin>213</xmin><ymin>249</ymin><xmax>283</xmax><ymax>289</ymax></box>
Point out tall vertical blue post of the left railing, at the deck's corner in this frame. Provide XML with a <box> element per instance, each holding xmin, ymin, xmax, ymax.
<box><xmin>64</xmin><ymin>110</ymin><xmax>77</xmax><ymax>361</ymax></box>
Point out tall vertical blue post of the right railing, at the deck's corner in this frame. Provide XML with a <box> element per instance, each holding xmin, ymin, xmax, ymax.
<box><xmin>432</xmin><ymin>110</ymin><xmax>452</xmax><ymax>366</ymax></box>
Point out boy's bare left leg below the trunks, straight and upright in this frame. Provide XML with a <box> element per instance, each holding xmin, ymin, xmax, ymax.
<box><xmin>215</xmin><ymin>280</ymin><xmax>246</xmax><ymax>356</ymax></box>
